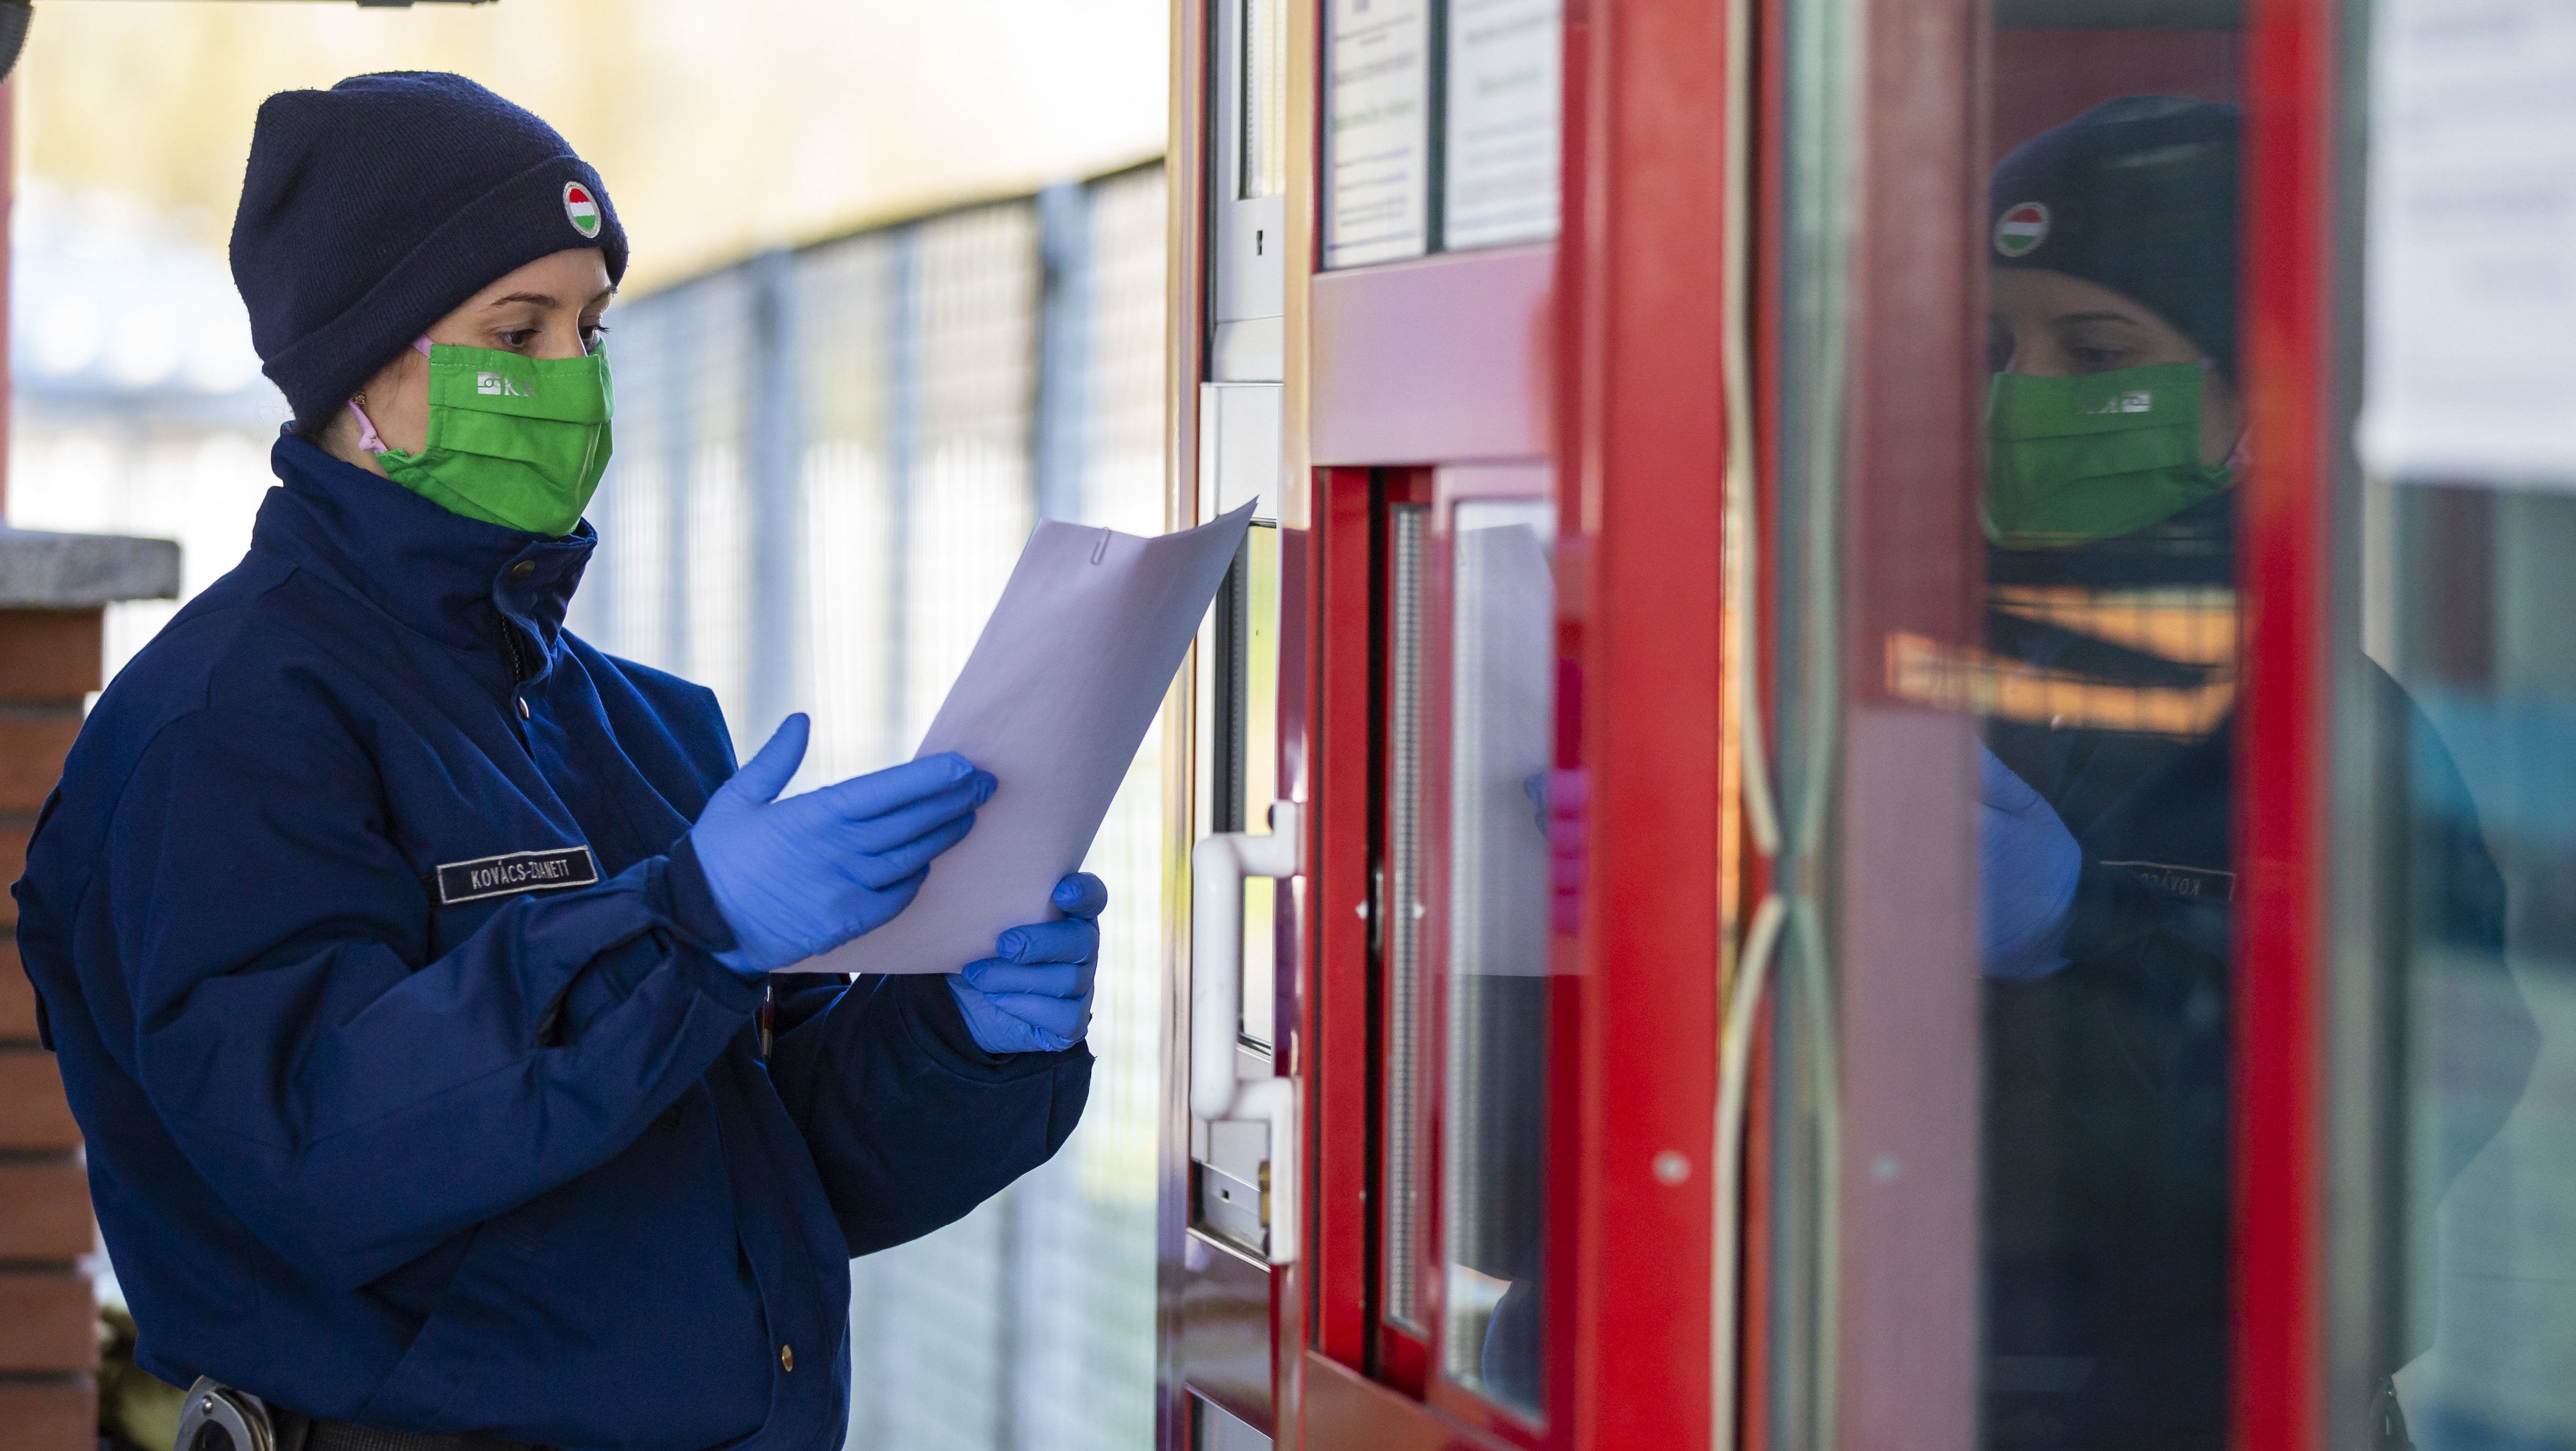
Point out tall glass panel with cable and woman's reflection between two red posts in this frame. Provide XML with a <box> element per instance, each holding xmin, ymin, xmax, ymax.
<box><xmin>1729</xmin><ymin>0</ymin><xmax>2267</xmax><ymax>1451</ymax></box>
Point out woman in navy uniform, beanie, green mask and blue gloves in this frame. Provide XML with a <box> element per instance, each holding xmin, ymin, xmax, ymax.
<box><xmin>15</xmin><ymin>72</ymin><xmax>1105</xmax><ymax>1451</ymax></box>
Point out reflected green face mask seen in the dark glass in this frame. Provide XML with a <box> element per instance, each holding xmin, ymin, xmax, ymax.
<box><xmin>1986</xmin><ymin>363</ymin><xmax>2231</xmax><ymax>549</ymax></box>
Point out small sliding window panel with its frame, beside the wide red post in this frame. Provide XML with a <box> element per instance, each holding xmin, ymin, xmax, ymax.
<box><xmin>1378</xmin><ymin>466</ymin><xmax>1582</xmax><ymax>1425</ymax></box>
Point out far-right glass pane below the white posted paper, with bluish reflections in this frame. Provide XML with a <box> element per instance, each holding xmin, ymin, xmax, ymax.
<box><xmin>2360</xmin><ymin>485</ymin><xmax>2576</xmax><ymax>1451</ymax></box>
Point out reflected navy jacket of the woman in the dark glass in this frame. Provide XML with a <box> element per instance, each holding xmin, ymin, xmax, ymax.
<box><xmin>1983</xmin><ymin>495</ymin><xmax>2540</xmax><ymax>1451</ymax></box>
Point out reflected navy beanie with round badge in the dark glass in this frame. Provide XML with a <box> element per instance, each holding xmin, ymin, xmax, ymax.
<box><xmin>1986</xmin><ymin>96</ymin><xmax>2239</xmax><ymax>377</ymax></box>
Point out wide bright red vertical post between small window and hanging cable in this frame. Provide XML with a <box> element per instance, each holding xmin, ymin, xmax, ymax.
<box><xmin>1548</xmin><ymin>0</ymin><xmax>1729</xmax><ymax>1446</ymax></box>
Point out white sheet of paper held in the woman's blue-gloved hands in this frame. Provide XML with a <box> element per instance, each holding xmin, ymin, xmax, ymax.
<box><xmin>791</xmin><ymin>503</ymin><xmax>1252</xmax><ymax>972</ymax></box>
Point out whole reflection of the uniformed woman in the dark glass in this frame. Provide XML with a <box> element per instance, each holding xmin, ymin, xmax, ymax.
<box><xmin>1947</xmin><ymin>96</ymin><xmax>2532</xmax><ymax>1451</ymax></box>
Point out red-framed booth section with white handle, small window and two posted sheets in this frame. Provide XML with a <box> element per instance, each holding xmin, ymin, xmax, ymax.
<box><xmin>1165</xmin><ymin>0</ymin><xmax>1731</xmax><ymax>1451</ymax></box>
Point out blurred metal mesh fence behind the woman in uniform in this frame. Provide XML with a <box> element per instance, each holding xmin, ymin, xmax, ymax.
<box><xmin>572</xmin><ymin>168</ymin><xmax>1167</xmax><ymax>1451</ymax></box>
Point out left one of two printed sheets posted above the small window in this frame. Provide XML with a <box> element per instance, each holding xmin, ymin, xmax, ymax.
<box><xmin>1324</xmin><ymin>0</ymin><xmax>1432</xmax><ymax>268</ymax></box>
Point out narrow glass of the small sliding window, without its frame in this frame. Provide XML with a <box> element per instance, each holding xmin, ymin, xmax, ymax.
<box><xmin>1440</xmin><ymin>500</ymin><xmax>1556</xmax><ymax>1410</ymax></box>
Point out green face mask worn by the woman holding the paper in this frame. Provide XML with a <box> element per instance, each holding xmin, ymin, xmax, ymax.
<box><xmin>358</xmin><ymin>343</ymin><xmax>616</xmax><ymax>534</ymax></box>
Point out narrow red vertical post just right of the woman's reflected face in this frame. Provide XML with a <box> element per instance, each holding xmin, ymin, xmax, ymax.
<box><xmin>2234</xmin><ymin>0</ymin><xmax>2339</xmax><ymax>1451</ymax></box>
